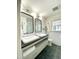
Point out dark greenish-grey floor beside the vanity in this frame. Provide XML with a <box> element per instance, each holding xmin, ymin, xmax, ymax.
<box><xmin>35</xmin><ymin>44</ymin><xmax>61</xmax><ymax>59</ymax></box>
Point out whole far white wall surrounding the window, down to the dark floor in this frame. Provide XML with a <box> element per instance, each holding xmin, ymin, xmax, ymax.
<box><xmin>47</xmin><ymin>13</ymin><xmax>61</xmax><ymax>46</ymax></box>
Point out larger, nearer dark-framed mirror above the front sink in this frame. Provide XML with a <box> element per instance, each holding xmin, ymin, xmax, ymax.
<box><xmin>21</xmin><ymin>12</ymin><xmax>33</xmax><ymax>35</ymax></box>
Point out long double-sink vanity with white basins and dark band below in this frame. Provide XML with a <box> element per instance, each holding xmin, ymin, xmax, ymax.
<box><xmin>21</xmin><ymin>33</ymin><xmax>48</xmax><ymax>59</ymax></box>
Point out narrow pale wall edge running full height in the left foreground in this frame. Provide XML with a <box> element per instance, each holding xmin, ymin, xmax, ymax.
<box><xmin>17</xmin><ymin>0</ymin><xmax>22</xmax><ymax>59</ymax></box>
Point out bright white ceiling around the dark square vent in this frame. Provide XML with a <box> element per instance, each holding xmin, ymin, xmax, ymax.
<box><xmin>21</xmin><ymin>0</ymin><xmax>61</xmax><ymax>16</ymax></box>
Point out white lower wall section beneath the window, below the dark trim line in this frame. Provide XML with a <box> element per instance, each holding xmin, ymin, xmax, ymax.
<box><xmin>49</xmin><ymin>32</ymin><xmax>61</xmax><ymax>46</ymax></box>
